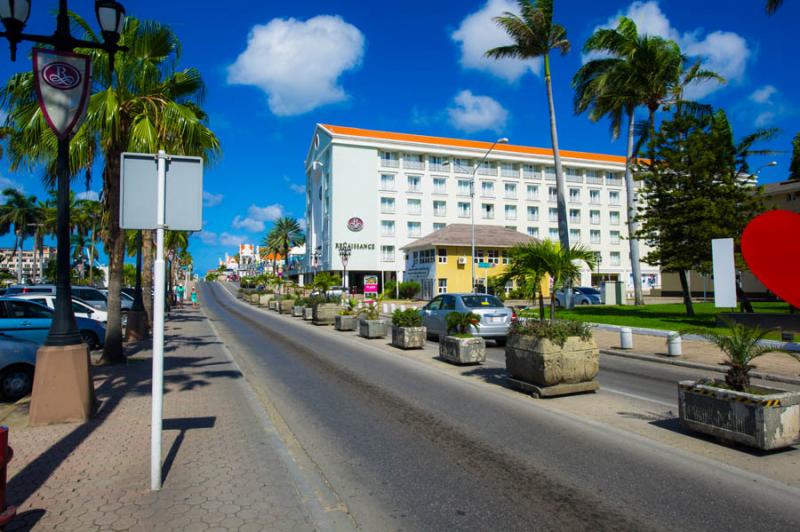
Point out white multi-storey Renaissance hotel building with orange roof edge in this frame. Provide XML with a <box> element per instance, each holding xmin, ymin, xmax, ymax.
<box><xmin>305</xmin><ymin>124</ymin><xmax>660</xmax><ymax>296</ymax></box>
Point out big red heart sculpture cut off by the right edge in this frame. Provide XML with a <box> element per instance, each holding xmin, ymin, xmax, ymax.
<box><xmin>742</xmin><ymin>210</ymin><xmax>800</xmax><ymax>307</ymax></box>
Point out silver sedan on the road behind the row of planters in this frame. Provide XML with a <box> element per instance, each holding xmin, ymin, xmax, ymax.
<box><xmin>421</xmin><ymin>294</ymin><xmax>516</xmax><ymax>346</ymax></box>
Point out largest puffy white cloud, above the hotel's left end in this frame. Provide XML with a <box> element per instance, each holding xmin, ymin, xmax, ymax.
<box><xmin>228</xmin><ymin>15</ymin><xmax>364</xmax><ymax>116</ymax></box>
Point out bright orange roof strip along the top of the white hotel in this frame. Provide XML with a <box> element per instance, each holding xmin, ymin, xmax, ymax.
<box><xmin>321</xmin><ymin>124</ymin><xmax>625</xmax><ymax>164</ymax></box>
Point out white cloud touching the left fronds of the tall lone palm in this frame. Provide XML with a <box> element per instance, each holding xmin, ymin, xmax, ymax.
<box><xmin>450</xmin><ymin>0</ymin><xmax>542</xmax><ymax>82</ymax></box>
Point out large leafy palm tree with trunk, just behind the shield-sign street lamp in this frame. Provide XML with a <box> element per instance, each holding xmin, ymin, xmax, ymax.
<box><xmin>2</xmin><ymin>15</ymin><xmax>220</xmax><ymax>363</ymax></box>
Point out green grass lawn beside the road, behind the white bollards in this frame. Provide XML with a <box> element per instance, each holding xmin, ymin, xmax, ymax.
<box><xmin>536</xmin><ymin>302</ymin><xmax>788</xmax><ymax>336</ymax></box>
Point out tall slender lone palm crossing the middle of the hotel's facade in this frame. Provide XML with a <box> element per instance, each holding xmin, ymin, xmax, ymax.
<box><xmin>486</xmin><ymin>0</ymin><xmax>570</xmax><ymax>255</ymax></box>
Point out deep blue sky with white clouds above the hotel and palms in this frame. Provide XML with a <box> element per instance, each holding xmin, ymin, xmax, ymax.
<box><xmin>0</xmin><ymin>0</ymin><xmax>800</xmax><ymax>271</ymax></box>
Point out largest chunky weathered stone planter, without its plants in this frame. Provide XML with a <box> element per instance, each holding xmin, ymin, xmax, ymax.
<box><xmin>506</xmin><ymin>334</ymin><xmax>600</xmax><ymax>397</ymax></box>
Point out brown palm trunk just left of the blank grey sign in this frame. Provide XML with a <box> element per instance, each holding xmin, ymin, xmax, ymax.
<box><xmin>101</xmin><ymin>149</ymin><xmax>125</xmax><ymax>364</ymax></box>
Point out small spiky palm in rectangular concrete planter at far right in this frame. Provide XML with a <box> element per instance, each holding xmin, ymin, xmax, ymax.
<box><xmin>678</xmin><ymin>322</ymin><xmax>800</xmax><ymax>450</ymax></box>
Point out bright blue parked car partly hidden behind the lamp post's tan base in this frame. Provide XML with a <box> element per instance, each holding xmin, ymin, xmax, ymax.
<box><xmin>0</xmin><ymin>297</ymin><xmax>106</xmax><ymax>349</ymax></box>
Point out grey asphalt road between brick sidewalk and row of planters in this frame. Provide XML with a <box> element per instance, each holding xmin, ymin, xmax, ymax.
<box><xmin>201</xmin><ymin>283</ymin><xmax>800</xmax><ymax>530</ymax></box>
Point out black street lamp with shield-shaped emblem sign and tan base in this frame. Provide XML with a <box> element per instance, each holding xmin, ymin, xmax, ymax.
<box><xmin>0</xmin><ymin>0</ymin><xmax>127</xmax><ymax>425</ymax></box>
